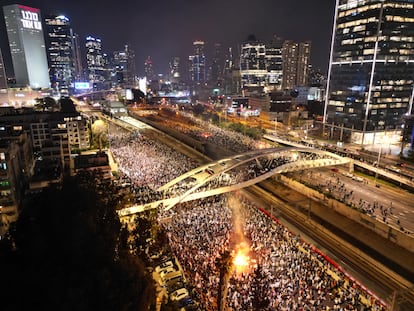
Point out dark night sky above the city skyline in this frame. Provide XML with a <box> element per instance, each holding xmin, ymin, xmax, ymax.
<box><xmin>0</xmin><ymin>0</ymin><xmax>335</xmax><ymax>75</ymax></box>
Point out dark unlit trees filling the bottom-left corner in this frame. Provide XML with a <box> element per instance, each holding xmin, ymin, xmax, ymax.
<box><xmin>0</xmin><ymin>172</ymin><xmax>155</xmax><ymax>310</ymax></box>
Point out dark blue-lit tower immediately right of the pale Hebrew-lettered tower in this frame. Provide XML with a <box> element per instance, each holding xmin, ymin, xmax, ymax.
<box><xmin>45</xmin><ymin>15</ymin><xmax>74</xmax><ymax>93</ymax></box>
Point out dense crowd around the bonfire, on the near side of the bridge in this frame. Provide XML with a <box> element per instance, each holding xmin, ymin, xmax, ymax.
<box><xmin>160</xmin><ymin>195</ymin><xmax>385</xmax><ymax>310</ymax></box>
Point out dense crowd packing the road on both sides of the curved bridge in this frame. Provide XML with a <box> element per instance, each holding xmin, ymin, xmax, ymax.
<box><xmin>106</xmin><ymin>116</ymin><xmax>385</xmax><ymax>310</ymax></box>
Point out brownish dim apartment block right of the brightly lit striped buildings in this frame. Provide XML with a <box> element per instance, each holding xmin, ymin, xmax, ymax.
<box><xmin>282</xmin><ymin>40</ymin><xmax>311</xmax><ymax>90</ymax></box>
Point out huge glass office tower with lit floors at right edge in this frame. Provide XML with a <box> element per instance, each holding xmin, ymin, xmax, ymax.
<box><xmin>324</xmin><ymin>0</ymin><xmax>414</xmax><ymax>144</ymax></box>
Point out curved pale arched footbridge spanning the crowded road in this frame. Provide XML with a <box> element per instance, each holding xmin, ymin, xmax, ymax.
<box><xmin>118</xmin><ymin>147</ymin><xmax>352</xmax><ymax>217</ymax></box>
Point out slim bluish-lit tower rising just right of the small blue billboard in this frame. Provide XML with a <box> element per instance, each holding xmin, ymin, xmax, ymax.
<box><xmin>86</xmin><ymin>36</ymin><xmax>105</xmax><ymax>89</ymax></box>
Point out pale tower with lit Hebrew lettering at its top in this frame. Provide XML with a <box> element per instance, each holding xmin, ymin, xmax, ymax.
<box><xmin>3</xmin><ymin>4</ymin><xmax>50</xmax><ymax>88</ymax></box>
